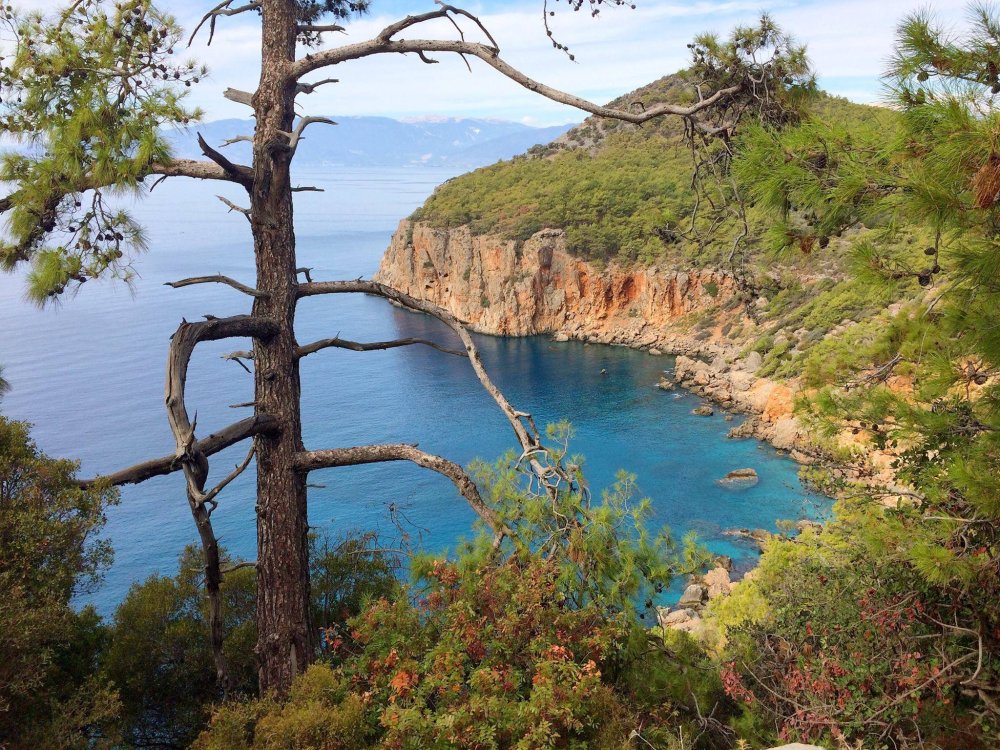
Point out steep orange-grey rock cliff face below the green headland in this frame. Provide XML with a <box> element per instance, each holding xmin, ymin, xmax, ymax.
<box><xmin>376</xmin><ymin>220</ymin><xmax>734</xmax><ymax>352</ymax></box>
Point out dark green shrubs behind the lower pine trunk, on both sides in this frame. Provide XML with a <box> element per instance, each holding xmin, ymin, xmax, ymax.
<box><xmin>101</xmin><ymin>535</ymin><xmax>399</xmax><ymax>747</ymax></box>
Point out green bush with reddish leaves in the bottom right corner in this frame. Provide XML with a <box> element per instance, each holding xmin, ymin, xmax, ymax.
<box><xmin>714</xmin><ymin>499</ymin><xmax>1000</xmax><ymax>750</ymax></box>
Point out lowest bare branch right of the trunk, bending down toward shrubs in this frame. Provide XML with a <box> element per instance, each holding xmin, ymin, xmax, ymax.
<box><xmin>295</xmin><ymin>443</ymin><xmax>512</xmax><ymax>536</ymax></box>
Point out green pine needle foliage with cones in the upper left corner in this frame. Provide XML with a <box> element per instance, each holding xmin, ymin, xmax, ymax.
<box><xmin>0</xmin><ymin>0</ymin><xmax>205</xmax><ymax>304</ymax></box>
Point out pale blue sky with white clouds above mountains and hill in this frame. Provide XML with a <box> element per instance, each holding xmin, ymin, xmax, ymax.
<box><xmin>27</xmin><ymin>0</ymin><xmax>967</xmax><ymax>125</ymax></box>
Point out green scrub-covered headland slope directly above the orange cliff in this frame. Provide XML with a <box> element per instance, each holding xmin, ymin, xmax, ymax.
<box><xmin>413</xmin><ymin>73</ymin><xmax>891</xmax><ymax>265</ymax></box>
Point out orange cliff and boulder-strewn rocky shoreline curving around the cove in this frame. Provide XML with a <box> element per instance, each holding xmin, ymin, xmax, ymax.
<box><xmin>375</xmin><ymin>220</ymin><xmax>908</xmax><ymax>633</ymax></box>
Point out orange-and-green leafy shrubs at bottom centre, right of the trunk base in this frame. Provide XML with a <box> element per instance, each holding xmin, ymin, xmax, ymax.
<box><xmin>195</xmin><ymin>446</ymin><xmax>730</xmax><ymax>750</ymax></box>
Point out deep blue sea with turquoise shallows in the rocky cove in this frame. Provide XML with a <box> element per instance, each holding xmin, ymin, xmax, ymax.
<box><xmin>0</xmin><ymin>168</ymin><xmax>828</xmax><ymax>614</ymax></box>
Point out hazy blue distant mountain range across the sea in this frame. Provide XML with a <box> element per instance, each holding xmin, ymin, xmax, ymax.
<box><xmin>160</xmin><ymin>116</ymin><xmax>573</xmax><ymax>169</ymax></box>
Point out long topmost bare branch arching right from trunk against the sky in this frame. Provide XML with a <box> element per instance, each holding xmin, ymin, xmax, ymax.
<box><xmin>291</xmin><ymin>38</ymin><xmax>739</xmax><ymax>124</ymax></box>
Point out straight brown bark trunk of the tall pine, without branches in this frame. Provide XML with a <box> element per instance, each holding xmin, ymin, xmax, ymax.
<box><xmin>250</xmin><ymin>0</ymin><xmax>313</xmax><ymax>694</ymax></box>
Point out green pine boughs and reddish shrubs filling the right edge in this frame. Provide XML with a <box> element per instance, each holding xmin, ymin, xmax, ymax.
<box><xmin>712</xmin><ymin>5</ymin><xmax>1000</xmax><ymax>748</ymax></box>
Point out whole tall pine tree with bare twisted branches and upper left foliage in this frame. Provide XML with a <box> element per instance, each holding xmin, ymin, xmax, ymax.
<box><xmin>0</xmin><ymin>0</ymin><xmax>804</xmax><ymax>694</ymax></box>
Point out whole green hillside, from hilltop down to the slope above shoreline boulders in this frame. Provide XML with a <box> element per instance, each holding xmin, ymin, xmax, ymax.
<box><xmin>412</xmin><ymin>73</ymin><xmax>924</xmax><ymax>385</ymax></box>
